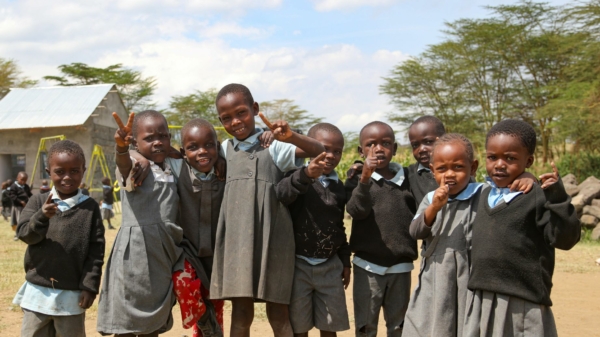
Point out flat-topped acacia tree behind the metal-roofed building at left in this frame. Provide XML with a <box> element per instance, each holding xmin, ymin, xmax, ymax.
<box><xmin>44</xmin><ymin>63</ymin><xmax>156</xmax><ymax>111</ymax></box>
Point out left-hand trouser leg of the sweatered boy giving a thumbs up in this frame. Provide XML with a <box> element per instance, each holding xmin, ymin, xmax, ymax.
<box><xmin>353</xmin><ymin>267</ymin><xmax>386</xmax><ymax>337</ymax></box>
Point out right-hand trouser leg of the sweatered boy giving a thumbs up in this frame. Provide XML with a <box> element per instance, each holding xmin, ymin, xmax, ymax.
<box><xmin>383</xmin><ymin>272</ymin><xmax>410</xmax><ymax>337</ymax></box>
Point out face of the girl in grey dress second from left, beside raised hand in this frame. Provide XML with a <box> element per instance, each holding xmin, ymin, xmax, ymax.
<box><xmin>133</xmin><ymin>117</ymin><xmax>171</xmax><ymax>164</ymax></box>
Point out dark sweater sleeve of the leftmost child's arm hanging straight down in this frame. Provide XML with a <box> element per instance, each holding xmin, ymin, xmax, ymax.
<box><xmin>79</xmin><ymin>203</ymin><xmax>105</xmax><ymax>294</ymax></box>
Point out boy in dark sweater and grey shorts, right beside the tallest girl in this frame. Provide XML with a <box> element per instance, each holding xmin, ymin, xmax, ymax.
<box><xmin>276</xmin><ymin>123</ymin><xmax>351</xmax><ymax>337</ymax></box>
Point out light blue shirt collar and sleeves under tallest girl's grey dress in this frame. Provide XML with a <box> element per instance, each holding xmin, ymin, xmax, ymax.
<box><xmin>221</xmin><ymin>129</ymin><xmax>301</xmax><ymax>172</ymax></box>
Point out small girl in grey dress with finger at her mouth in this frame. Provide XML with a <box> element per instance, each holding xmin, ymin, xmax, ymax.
<box><xmin>403</xmin><ymin>133</ymin><xmax>489</xmax><ymax>336</ymax></box>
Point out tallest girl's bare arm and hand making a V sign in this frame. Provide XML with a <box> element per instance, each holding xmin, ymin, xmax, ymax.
<box><xmin>258</xmin><ymin>112</ymin><xmax>325</xmax><ymax>158</ymax></box>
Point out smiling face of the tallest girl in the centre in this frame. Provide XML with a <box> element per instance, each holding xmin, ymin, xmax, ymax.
<box><xmin>217</xmin><ymin>93</ymin><xmax>258</xmax><ymax>140</ymax></box>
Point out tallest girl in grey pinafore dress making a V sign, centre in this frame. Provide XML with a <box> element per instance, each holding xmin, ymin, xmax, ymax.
<box><xmin>210</xmin><ymin>84</ymin><xmax>324</xmax><ymax>336</ymax></box>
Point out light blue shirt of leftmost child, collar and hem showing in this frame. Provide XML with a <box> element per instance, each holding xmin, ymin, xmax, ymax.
<box><xmin>13</xmin><ymin>187</ymin><xmax>89</xmax><ymax>316</ymax></box>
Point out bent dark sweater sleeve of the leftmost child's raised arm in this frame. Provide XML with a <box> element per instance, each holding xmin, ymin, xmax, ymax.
<box><xmin>17</xmin><ymin>194</ymin><xmax>50</xmax><ymax>245</ymax></box>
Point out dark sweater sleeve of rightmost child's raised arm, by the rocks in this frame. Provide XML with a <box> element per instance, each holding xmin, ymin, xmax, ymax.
<box><xmin>537</xmin><ymin>179</ymin><xmax>581</xmax><ymax>250</ymax></box>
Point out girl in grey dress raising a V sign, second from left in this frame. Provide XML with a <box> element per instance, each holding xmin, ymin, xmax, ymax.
<box><xmin>97</xmin><ymin>110</ymin><xmax>183</xmax><ymax>336</ymax></box>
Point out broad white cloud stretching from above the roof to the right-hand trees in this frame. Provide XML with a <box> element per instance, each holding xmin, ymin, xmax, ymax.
<box><xmin>0</xmin><ymin>0</ymin><xmax>407</xmax><ymax>131</ymax></box>
